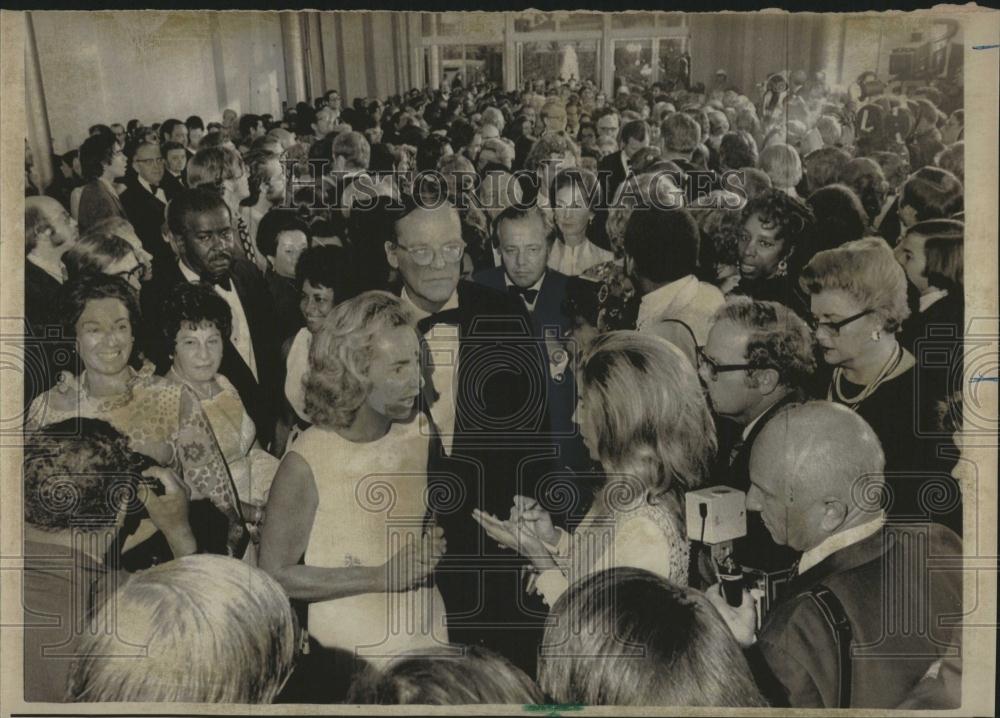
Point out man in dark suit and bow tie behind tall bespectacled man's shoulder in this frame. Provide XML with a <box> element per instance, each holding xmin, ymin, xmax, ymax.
<box><xmin>473</xmin><ymin>207</ymin><xmax>590</xmax><ymax>470</ymax></box>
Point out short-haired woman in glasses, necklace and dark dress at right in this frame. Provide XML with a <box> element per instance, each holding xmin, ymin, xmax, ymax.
<box><xmin>800</xmin><ymin>238</ymin><xmax>961</xmax><ymax>529</ymax></box>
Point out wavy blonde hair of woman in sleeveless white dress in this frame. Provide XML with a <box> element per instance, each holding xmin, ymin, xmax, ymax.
<box><xmin>305</xmin><ymin>291</ymin><xmax>416</xmax><ymax>429</ymax></box>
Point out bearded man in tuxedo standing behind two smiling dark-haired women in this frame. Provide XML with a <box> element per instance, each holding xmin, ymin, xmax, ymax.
<box><xmin>140</xmin><ymin>188</ymin><xmax>278</xmax><ymax>447</ymax></box>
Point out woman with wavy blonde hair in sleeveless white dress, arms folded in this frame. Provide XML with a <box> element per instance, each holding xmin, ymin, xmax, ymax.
<box><xmin>260</xmin><ymin>291</ymin><xmax>448</xmax><ymax>671</ymax></box>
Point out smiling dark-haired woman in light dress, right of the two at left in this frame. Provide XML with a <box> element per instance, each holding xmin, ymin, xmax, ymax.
<box><xmin>162</xmin><ymin>282</ymin><xmax>278</xmax><ymax>563</ymax></box>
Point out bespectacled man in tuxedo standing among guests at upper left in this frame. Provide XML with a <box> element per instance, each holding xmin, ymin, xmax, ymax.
<box><xmin>121</xmin><ymin>142</ymin><xmax>174</xmax><ymax>263</ymax></box>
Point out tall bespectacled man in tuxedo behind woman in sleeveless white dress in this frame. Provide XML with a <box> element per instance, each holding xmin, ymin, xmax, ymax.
<box><xmin>382</xmin><ymin>197</ymin><xmax>553</xmax><ymax>674</ymax></box>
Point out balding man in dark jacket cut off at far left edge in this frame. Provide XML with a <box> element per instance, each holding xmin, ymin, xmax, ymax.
<box><xmin>24</xmin><ymin>196</ymin><xmax>80</xmax><ymax>406</ymax></box>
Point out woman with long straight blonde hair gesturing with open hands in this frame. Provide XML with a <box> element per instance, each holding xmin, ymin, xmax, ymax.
<box><xmin>473</xmin><ymin>331</ymin><xmax>716</xmax><ymax>607</ymax></box>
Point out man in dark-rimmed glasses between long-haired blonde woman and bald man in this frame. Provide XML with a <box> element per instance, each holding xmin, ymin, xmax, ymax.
<box><xmin>698</xmin><ymin>297</ymin><xmax>816</xmax><ymax>571</ymax></box>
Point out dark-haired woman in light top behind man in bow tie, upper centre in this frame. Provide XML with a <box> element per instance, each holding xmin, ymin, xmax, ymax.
<box><xmin>548</xmin><ymin>167</ymin><xmax>615</xmax><ymax>277</ymax></box>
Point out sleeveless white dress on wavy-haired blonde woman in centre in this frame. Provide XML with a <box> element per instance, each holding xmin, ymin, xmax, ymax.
<box><xmin>289</xmin><ymin>420</ymin><xmax>448</xmax><ymax>666</ymax></box>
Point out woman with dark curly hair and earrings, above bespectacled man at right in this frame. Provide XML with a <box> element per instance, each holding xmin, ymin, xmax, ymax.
<box><xmin>734</xmin><ymin>189</ymin><xmax>815</xmax><ymax>317</ymax></box>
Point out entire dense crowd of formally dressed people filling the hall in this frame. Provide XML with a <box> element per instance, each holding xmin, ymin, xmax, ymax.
<box><xmin>24</xmin><ymin>62</ymin><xmax>964</xmax><ymax>708</ymax></box>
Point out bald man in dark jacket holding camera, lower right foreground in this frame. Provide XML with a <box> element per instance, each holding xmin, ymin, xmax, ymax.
<box><xmin>708</xmin><ymin>401</ymin><xmax>962</xmax><ymax>708</ymax></box>
